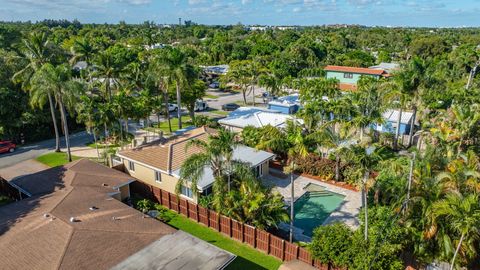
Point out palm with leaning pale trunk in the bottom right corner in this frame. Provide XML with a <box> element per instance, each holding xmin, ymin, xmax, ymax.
<box><xmin>433</xmin><ymin>193</ymin><xmax>480</xmax><ymax>270</ymax></box>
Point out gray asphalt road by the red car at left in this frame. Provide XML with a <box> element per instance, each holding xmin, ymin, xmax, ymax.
<box><xmin>0</xmin><ymin>131</ymin><xmax>93</xmax><ymax>168</ymax></box>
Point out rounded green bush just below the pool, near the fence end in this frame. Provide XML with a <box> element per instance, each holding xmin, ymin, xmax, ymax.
<box><xmin>309</xmin><ymin>223</ymin><xmax>353</xmax><ymax>267</ymax></box>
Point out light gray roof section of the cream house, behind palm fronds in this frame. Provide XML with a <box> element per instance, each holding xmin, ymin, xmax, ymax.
<box><xmin>173</xmin><ymin>145</ymin><xmax>275</xmax><ymax>190</ymax></box>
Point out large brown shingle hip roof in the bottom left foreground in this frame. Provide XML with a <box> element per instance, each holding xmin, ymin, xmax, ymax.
<box><xmin>0</xmin><ymin>159</ymin><xmax>175</xmax><ymax>269</ymax></box>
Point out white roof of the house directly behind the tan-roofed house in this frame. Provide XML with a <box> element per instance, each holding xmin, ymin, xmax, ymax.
<box><xmin>218</xmin><ymin>107</ymin><xmax>292</xmax><ymax>128</ymax></box>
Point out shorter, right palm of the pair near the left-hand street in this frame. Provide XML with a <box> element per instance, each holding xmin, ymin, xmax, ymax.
<box><xmin>31</xmin><ymin>63</ymin><xmax>83</xmax><ymax>162</ymax></box>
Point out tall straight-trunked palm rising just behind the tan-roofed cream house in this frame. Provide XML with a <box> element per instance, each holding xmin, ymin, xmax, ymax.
<box><xmin>161</xmin><ymin>48</ymin><xmax>195</xmax><ymax>129</ymax></box>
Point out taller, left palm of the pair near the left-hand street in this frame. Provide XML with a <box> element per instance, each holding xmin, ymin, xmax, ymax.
<box><xmin>12</xmin><ymin>32</ymin><xmax>60</xmax><ymax>152</ymax></box>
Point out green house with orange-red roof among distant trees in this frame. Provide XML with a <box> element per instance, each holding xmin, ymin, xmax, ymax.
<box><xmin>324</xmin><ymin>65</ymin><xmax>391</xmax><ymax>91</ymax></box>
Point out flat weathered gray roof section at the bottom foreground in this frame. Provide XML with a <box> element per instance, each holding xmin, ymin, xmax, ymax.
<box><xmin>112</xmin><ymin>231</ymin><xmax>236</xmax><ymax>270</ymax></box>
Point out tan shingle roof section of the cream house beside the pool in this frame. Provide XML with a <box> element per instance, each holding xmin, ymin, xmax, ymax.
<box><xmin>119</xmin><ymin>127</ymin><xmax>216</xmax><ymax>172</ymax></box>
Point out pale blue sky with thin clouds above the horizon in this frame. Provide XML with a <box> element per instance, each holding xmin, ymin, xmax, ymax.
<box><xmin>0</xmin><ymin>0</ymin><xmax>480</xmax><ymax>27</ymax></box>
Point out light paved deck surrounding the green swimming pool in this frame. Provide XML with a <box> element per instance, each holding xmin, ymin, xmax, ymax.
<box><xmin>263</xmin><ymin>168</ymin><xmax>362</xmax><ymax>241</ymax></box>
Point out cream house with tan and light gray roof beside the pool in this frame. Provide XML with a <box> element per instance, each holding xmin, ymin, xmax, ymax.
<box><xmin>117</xmin><ymin>127</ymin><xmax>275</xmax><ymax>202</ymax></box>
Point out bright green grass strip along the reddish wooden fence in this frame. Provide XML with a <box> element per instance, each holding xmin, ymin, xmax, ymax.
<box><xmin>168</xmin><ymin>215</ymin><xmax>282</xmax><ymax>270</ymax></box>
